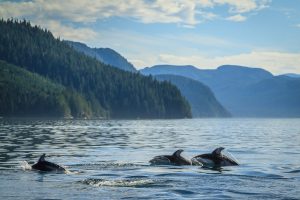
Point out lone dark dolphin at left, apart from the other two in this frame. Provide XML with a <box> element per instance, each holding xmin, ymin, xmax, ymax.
<box><xmin>31</xmin><ymin>154</ymin><xmax>67</xmax><ymax>172</ymax></box>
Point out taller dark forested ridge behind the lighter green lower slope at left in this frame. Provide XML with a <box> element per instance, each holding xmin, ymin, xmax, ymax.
<box><xmin>0</xmin><ymin>20</ymin><xmax>191</xmax><ymax>118</ymax></box>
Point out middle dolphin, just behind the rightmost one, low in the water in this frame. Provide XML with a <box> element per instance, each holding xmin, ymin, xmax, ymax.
<box><xmin>149</xmin><ymin>149</ymin><xmax>192</xmax><ymax>165</ymax></box>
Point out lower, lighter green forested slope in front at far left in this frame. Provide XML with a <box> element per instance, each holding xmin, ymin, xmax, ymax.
<box><xmin>0</xmin><ymin>60</ymin><xmax>105</xmax><ymax>118</ymax></box>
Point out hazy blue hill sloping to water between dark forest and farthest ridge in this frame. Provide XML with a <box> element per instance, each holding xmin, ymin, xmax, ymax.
<box><xmin>155</xmin><ymin>75</ymin><xmax>230</xmax><ymax>117</ymax></box>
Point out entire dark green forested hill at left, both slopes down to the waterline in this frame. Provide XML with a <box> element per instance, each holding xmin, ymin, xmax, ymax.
<box><xmin>0</xmin><ymin>20</ymin><xmax>191</xmax><ymax>118</ymax></box>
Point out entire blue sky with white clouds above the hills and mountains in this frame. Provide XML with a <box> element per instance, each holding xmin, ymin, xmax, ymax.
<box><xmin>0</xmin><ymin>0</ymin><xmax>300</xmax><ymax>74</ymax></box>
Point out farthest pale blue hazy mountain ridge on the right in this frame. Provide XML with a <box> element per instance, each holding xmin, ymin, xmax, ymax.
<box><xmin>141</xmin><ymin>65</ymin><xmax>300</xmax><ymax>117</ymax></box>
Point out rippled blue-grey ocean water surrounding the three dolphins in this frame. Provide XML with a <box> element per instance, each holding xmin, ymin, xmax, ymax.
<box><xmin>0</xmin><ymin>118</ymin><xmax>300</xmax><ymax>199</ymax></box>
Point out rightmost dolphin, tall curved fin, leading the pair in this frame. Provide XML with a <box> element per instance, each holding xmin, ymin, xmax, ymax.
<box><xmin>192</xmin><ymin>147</ymin><xmax>239</xmax><ymax>167</ymax></box>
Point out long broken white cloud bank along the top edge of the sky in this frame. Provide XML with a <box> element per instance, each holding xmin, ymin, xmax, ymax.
<box><xmin>0</xmin><ymin>0</ymin><xmax>270</xmax><ymax>25</ymax></box>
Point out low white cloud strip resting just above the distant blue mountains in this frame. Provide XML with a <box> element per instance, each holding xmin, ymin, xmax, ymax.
<box><xmin>157</xmin><ymin>51</ymin><xmax>300</xmax><ymax>74</ymax></box>
